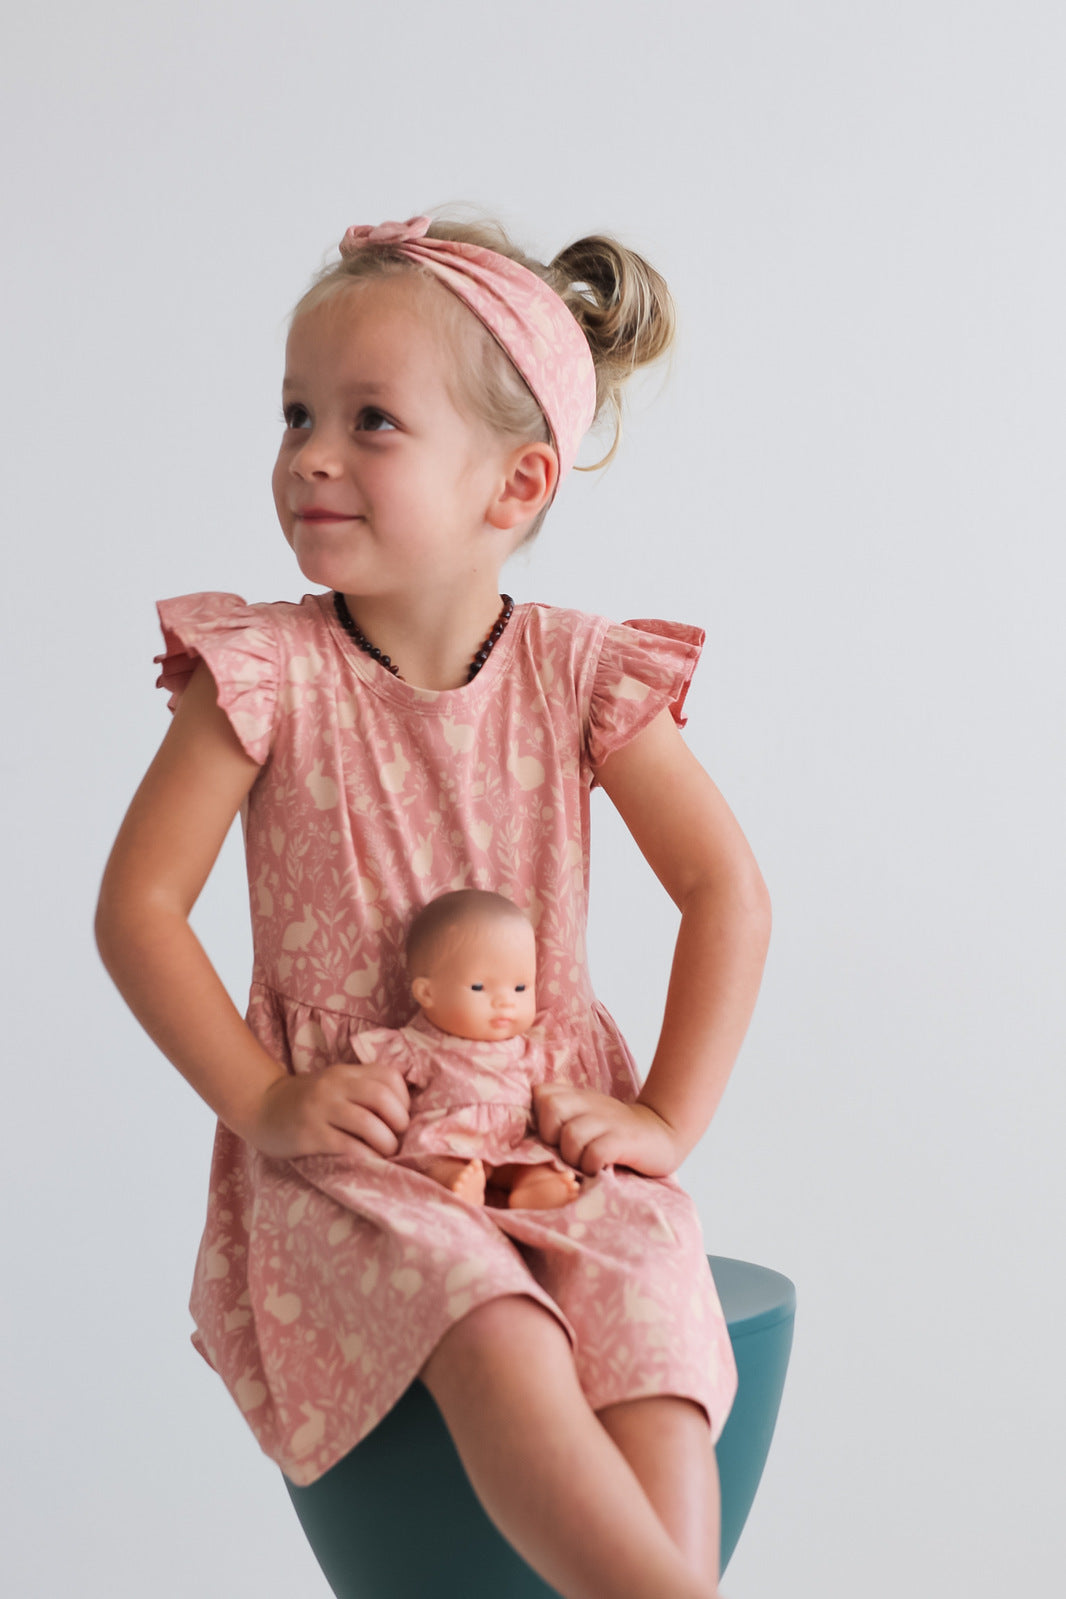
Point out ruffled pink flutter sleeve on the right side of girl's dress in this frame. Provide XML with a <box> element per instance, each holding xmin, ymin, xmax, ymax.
<box><xmin>587</xmin><ymin>619</ymin><xmax>706</xmax><ymax>772</ymax></box>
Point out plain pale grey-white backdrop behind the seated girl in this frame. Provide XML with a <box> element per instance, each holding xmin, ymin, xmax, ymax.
<box><xmin>0</xmin><ymin>0</ymin><xmax>1066</xmax><ymax>1599</ymax></box>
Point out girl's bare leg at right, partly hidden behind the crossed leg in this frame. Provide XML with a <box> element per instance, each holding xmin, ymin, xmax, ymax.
<box><xmin>598</xmin><ymin>1394</ymin><xmax>721</xmax><ymax>1581</ymax></box>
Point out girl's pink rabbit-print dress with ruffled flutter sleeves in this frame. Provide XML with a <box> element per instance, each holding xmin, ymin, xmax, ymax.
<box><xmin>158</xmin><ymin>593</ymin><xmax>735</xmax><ymax>1484</ymax></box>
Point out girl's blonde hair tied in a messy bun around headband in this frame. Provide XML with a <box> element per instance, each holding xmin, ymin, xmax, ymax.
<box><xmin>292</xmin><ymin>217</ymin><xmax>674</xmax><ymax>537</ymax></box>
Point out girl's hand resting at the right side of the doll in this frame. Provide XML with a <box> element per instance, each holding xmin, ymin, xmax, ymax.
<box><xmin>532</xmin><ymin>1083</ymin><xmax>684</xmax><ymax>1177</ymax></box>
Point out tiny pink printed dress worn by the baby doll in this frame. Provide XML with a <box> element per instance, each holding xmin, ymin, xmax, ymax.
<box><xmin>352</xmin><ymin>1014</ymin><xmax>572</xmax><ymax>1172</ymax></box>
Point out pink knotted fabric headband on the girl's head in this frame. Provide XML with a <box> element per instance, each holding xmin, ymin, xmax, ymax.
<box><xmin>340</xmin><ymin>216</ymin><xmax>596</xmax><ymax>480</ymax></box>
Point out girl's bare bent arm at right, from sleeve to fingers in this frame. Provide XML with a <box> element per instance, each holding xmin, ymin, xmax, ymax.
<box><xmin>535</xmin><ymin>710</ymin><xmax>770</xmax><ymax>1177</ymax></box>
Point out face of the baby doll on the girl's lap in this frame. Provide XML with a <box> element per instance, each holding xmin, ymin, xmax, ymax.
<box><xmin>411</xmin><ymin>918</ymin><xmax>537</xmax><ymax>1039</ymax></box>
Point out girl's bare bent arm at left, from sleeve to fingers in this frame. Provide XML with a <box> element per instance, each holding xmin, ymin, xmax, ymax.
<box><xmin>96</xmin><ymin>664</ymin><xmax>408</xmax><ymax>1156</ymax></box>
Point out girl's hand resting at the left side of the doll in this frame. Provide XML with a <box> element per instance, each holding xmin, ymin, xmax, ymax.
<box><xmin>240</xmin><ymin>1062</ymin><xmax>411</xmax><ymax>1159</ymax></box>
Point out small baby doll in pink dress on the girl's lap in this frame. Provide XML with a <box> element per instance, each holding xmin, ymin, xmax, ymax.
<box><xmin>353</xmin><ymin>889</ymin><xmax>580</xmax><ymax>1210</ymax></box>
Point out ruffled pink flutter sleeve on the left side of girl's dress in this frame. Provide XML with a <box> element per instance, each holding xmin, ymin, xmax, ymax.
<box><xmin>155</xmin><ymin>593</ymin><xmax>280</xmax><ymax>766</ymax></box>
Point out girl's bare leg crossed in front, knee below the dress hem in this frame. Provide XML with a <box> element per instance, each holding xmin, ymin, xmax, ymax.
<box><xmin>422</xmin><ymin>1295</ymin><xmax>716</xmax><ymax>1599</ymax></box>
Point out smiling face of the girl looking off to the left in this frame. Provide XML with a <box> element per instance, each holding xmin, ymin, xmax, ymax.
<box><xmin>273</xmin><ymin>275</ymin><xmax>507</xmax><ymax>596</ymax></box>
